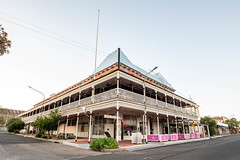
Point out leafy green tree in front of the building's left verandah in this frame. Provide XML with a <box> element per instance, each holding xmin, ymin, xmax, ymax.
<box><xmin>32</xmin><ymin>109</ymin><xmax>61</xmax><ymax>137</ymax></box>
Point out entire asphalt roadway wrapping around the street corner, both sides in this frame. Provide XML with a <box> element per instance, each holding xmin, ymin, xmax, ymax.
<box><xmin>0</xmin><ymin>131</ymin><xmax>240</xmax><ymax>160</ymax></box>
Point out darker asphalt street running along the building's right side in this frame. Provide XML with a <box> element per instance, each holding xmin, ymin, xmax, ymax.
<box><xmin>83</xmin><ymin>135</ymin><xmax>240</xmax><ymax>160</ymax></box>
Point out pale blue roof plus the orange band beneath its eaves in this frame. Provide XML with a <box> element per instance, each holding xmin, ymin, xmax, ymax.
<box><xmin>34</xmin><ymin>48</ymin><xmax>179</xmax><ymax>108</ymax></box>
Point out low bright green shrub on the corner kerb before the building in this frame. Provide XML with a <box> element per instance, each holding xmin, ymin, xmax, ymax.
<box><xmin>90</xmin><ymin>137</ymin><xmax>119</xmax><ymax>151</ymax></box>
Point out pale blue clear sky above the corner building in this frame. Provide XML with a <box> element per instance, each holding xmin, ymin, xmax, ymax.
<box><xmin>0</xmin><ymin>0</ymin><xmax>240</xmax><ymax>120</ymax></box>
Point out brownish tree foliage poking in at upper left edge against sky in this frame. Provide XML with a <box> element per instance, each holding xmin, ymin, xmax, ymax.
<box><xmin>0</xmin><ymin>25</ymin><xmax>12</xmax><ymax>56</ymax></box>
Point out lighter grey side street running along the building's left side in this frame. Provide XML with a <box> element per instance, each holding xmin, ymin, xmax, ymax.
<box><xmin>0</xmin><ymin>130</ymin><xmax>103</xmax><ymax>160</ymax></box>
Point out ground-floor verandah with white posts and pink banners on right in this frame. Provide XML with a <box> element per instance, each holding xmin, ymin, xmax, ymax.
<box><xmin>58</xmin><ymin>107</ymin><xmax>205</xmax><ymax>141</ymax></box>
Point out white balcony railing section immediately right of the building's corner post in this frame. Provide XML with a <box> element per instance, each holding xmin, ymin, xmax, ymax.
<box><xmin>119</xmin><ymin>88</ymin><xmax>144</xmax><ymax>103</ymax></box>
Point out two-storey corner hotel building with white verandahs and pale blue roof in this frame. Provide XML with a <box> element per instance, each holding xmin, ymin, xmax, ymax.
<box><xmin>20</xmin><ymin>48</ymin><xmax>202</xmax><ymax>141</ymax></box>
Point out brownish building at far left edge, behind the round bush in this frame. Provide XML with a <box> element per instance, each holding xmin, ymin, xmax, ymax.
<box><xmin>0</xmin><ymin>108</ymin><xmax>24</xmax><ymax>127</ymax></box>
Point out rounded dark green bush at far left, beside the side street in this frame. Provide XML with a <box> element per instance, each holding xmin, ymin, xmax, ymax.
<box><xmin>7</xmin><ymin>118</ymin><xmax>25</xmax><ymax>133</ymax></box>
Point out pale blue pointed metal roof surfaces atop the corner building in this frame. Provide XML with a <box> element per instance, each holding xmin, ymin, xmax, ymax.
<box><xmin>96</xmin><ymin>49</ymin><xmax>175</xmax><ymax>90</ymax></box>
